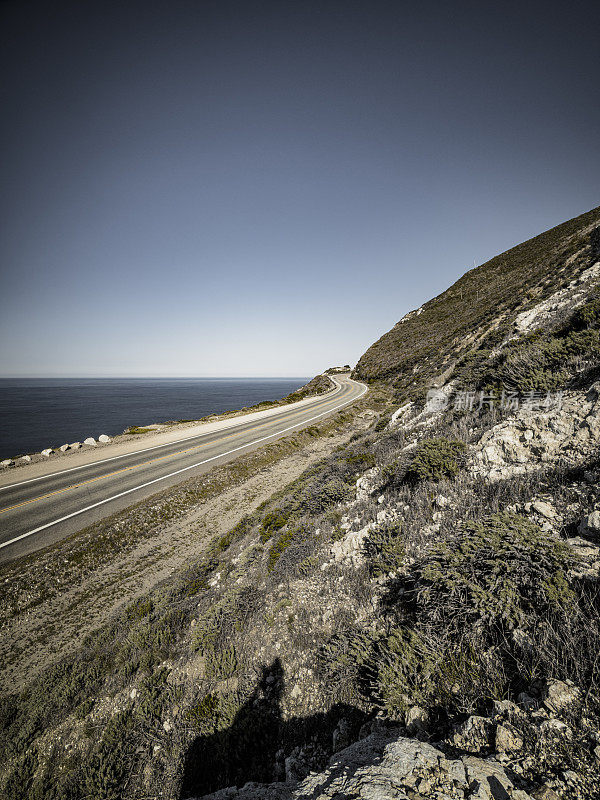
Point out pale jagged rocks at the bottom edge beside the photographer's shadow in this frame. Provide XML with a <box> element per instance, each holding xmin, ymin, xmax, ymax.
<box><xmin>201</xmin><ymin>681</ymin><xmax>600</xmax><ymax>800</ymax></box>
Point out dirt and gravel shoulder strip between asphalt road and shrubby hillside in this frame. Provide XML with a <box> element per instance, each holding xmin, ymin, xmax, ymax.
<box><xmin>0</xmin><ymin>407</ymin><xmax>371</xmax><ymax>690</ymax></box>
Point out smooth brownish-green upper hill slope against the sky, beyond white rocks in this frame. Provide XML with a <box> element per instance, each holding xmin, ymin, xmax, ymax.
<box><xmin>354</xmin><ymin>207</ymin><xmax>600</xmax><ymax>392</ymax></box>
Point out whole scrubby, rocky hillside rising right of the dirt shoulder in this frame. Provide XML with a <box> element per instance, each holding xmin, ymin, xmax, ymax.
<box><xmin>0</xmin><ymin>210</ymin><xmax>600</xmax><ymax>800</ymax></box>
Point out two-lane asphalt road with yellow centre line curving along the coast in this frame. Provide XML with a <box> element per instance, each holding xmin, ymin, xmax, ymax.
<box><xmin>0</xmin><ymin>376</ymin><xmax>366</xmax><ymax>561</ymax></box>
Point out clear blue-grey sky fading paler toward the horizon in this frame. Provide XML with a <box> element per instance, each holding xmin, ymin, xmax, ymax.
<box><xmin>0</xmin><ymin>0</ymin><xmax>600</xmax><ymax>376</ymax></box>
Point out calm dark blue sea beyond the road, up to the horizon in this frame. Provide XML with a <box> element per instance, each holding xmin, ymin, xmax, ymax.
<box><xmin>0</xmin><ymin>378</ymin><xmax>308</xmax><ymax>458</ymax></box>
